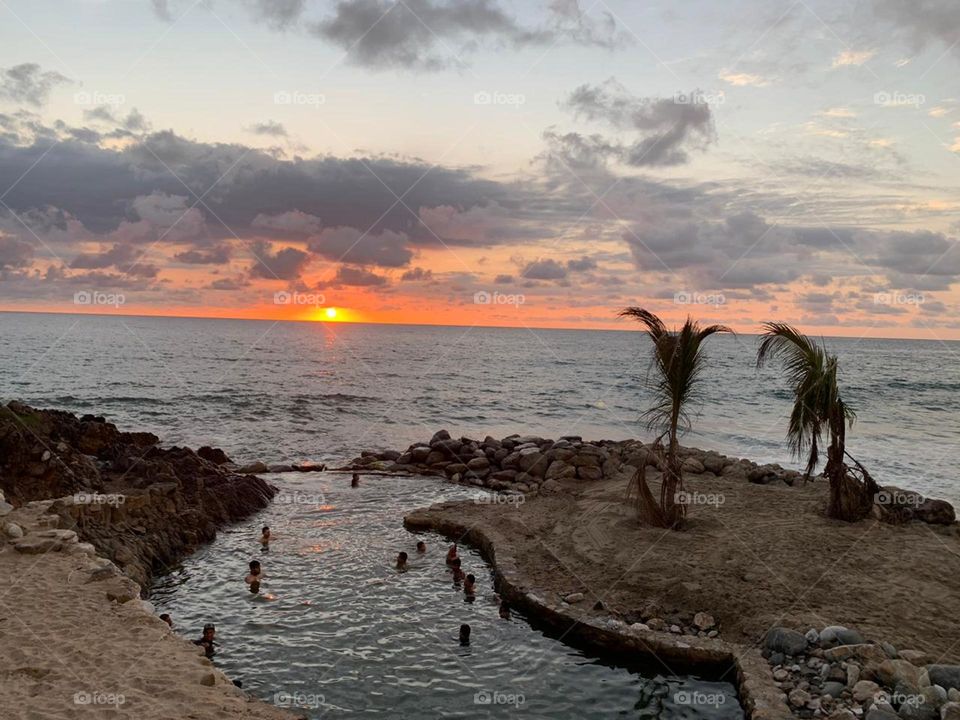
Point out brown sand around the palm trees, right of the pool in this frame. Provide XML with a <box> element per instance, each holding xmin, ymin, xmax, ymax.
<box><xmin>426</xmin><ymin>476</ymin><xmax>960</xmax><ymax>662</ymax></box>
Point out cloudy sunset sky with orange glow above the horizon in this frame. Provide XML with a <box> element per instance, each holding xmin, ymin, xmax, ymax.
<box><xmin>0</xmin><ymin>0</ymin><xmax>960</xmax><ymax>340</ymax></box>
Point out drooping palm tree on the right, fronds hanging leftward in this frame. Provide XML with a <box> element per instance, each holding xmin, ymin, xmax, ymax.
<box><xmin>757</xmin><ymin>322</ymin><xmax>879</xmax><ymax>522</ymax></box>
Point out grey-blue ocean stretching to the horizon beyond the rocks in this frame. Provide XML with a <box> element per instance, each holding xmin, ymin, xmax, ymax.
<box><xmin>0</xmin><ymin>313</ymin><xmax>960</xmax><ymax>503</ymax></box>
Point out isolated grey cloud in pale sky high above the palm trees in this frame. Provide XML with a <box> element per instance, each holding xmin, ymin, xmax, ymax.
<box><xmin>563</xmin><ymin>78</ymin><xmax>714</xmax><ymax>167</ymax></box>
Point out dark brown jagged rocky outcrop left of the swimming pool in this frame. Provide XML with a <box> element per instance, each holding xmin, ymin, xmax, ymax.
<box><xmin>0</xmin><ymin>402</ymin><xmax>276</xmax><ymax>587</ymax></box>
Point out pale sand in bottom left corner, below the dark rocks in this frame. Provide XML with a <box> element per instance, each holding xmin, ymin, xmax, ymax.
<box><xmin>0</xmin><ymin>508</ymin><xmax>294</xmax><ymax>720</ymax></box>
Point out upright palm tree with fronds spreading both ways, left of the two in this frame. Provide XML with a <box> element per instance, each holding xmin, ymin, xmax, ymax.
<box><xmin>620</xmin><ymin>307</ymin><xmax>733</xmax><ymax>529</ymax></box>
